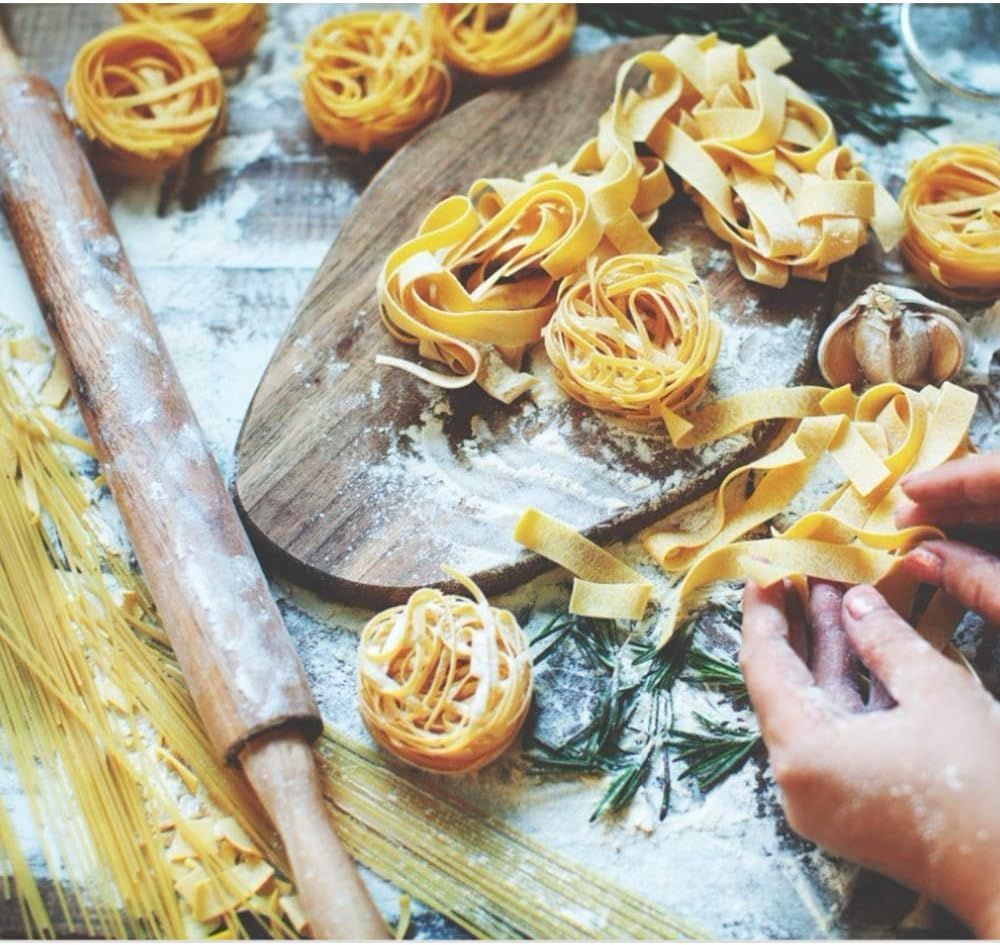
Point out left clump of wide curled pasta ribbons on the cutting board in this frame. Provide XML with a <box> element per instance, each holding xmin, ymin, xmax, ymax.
<box><xmin>376</xmin><ymin>52</ymin><xmax>672</xmax><ymax>403</ymax></box>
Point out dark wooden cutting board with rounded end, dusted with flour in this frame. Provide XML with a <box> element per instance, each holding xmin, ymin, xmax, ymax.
<box><xmin>235</xmin><ymin>38</ymin><xmax>835</xmax><ymax>607</ymax></box>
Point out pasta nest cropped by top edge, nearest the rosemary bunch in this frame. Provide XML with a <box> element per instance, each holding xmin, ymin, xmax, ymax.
<box><xmin>424</xmin><ymin>3</ymin><xmax>576</xmax><ymax>77</ymax></box>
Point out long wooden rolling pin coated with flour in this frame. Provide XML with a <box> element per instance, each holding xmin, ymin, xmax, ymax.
<box><xmin>0</xmin><ymin>28</ymin><xmax>387</xmax><ymax>939</ymax></box>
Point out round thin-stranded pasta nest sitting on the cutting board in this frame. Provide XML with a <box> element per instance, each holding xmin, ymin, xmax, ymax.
<box><xmin>544</xmin><ymin>253</ymin><xmax>722</xmax><ymax>424</ymax></box>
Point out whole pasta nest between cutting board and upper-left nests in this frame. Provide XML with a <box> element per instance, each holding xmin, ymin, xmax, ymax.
<box><xmin>302</xmin><ymin>12</ymin><xmax>451</xmax><ymax>154</ymax></box>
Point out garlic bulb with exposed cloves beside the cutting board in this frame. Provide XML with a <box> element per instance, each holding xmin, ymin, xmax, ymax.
<box><xmin>818</xmin><ymin>283</ymin><xmax>965</xmax><ymax>387</ymax></box>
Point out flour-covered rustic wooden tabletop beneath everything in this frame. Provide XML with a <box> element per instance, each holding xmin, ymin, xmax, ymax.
<box><xmin>0</xmin><ymin>4</ymin><xmax>1000</xmax><ymax>937</ymax></box>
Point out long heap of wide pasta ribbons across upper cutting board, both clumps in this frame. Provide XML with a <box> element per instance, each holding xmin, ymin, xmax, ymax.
<box><xmin>378</xmin><ymin>34</ymin><xmax>902</xmax><ymax>405</ymax></box>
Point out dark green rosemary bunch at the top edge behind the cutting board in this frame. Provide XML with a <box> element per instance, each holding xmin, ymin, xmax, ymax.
<box><xmin>579</xmin><ymin>3</ymin><xmax>947</xmax><ymax>144</ymax></box>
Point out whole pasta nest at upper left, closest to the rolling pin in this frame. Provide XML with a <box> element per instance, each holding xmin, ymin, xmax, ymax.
<box><xmin>66</xmin><ymin>23</ymin><xmax>225</xmax><ymax>177</ymax></box>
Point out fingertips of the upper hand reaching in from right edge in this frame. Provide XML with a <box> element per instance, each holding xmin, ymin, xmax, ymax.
<box><xmin>896</xmin><ymin>453</ymin><xmax>1000</xmax><ymax>624</ymax></box>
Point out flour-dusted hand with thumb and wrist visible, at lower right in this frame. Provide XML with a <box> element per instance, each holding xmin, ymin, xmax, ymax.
<box><xmin>740</xmin><ymin>582</ymin><xmax>1000</xmax><ymax>937</ymax></box>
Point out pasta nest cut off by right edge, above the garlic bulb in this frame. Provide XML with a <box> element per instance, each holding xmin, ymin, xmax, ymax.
<box><xmin>899</xmin><ymin>144</ymin><xmax>1000</xmax><ymax>300</ymax></box>
